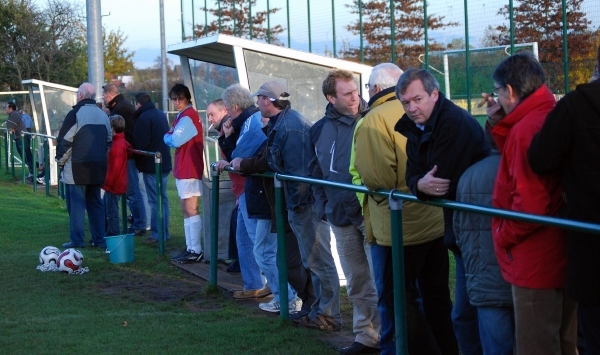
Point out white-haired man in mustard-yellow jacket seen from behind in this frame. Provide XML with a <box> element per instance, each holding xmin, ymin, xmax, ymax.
<box><xmin>351</xmin><ymin>63</ymin><xmax>457</xmax><ymax>355</ymax></box>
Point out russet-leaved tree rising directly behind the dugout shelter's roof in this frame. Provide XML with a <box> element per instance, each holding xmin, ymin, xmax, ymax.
<box><xmin>194</xmin><ymin>0</ymin><xmax>284</xmax><ymax>45</ymax></box>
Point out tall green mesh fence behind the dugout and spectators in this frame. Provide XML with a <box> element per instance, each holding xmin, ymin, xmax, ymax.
<box><xmin>180</xmin><ymin>0</ymin><xmax>600</xmax><ymax>115</ymax></box>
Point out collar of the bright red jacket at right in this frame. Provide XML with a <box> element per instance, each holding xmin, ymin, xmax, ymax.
<box><xmin>492</xmin><ymin>84</ymin><xmax>556</xmax><ymax>149</ymax></box>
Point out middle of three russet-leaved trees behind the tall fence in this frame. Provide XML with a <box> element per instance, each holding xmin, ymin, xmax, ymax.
<box><xmin>340</xmin><ymin>0</ymin><xmax>457</xmax><ymax>68</ymax></box>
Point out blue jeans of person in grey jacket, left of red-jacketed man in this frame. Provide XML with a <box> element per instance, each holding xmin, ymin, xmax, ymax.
<box><xmin>477</xmin><ymin>307</ymin><xmax>515</xmax><ymax>355</ymax></box>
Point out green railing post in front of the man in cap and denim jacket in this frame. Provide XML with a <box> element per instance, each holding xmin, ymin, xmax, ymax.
<box><xmin>273</xmin><ymin>174</ymin><xmax>290</xmax><ymax>320</ymax></box>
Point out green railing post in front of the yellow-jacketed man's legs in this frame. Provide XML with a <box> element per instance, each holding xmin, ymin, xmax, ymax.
<box><xmin>389</xmin><ymin>190</ymin><xmax>408</xmax><ymax>354</ymax></box>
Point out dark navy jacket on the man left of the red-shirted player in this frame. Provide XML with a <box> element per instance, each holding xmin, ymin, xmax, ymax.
<box><xmin>133</xmin><ymin>101</ymin><xmax>172</xmax><ymax>174</ymax></box>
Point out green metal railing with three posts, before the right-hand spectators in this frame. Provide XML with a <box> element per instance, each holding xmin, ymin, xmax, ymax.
<box><xmin>209</xmin><ymin>164</ymin><xmax>600</xmax><ymax>354</ymax></box>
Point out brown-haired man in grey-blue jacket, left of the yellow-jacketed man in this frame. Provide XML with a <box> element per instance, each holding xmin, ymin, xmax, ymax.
<box><xmin>310</xmin><ymin>69</ymin><xmax>381</xmax><ymax>354</ymax></box>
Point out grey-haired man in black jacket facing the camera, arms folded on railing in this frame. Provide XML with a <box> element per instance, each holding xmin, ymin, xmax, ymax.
<box><xmin>394</xmin><ymin>69</ymin><xmax>491</xmax><ymax>354</ymax></box>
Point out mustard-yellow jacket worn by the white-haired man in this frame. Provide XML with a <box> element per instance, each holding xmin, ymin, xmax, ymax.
<box><xmin>354</xmin><ymin>87</ymin><xmax>444</xmax><ymax>247</ymax></box>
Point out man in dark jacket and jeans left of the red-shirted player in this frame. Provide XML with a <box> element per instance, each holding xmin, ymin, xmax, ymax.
<box><xmin>133</xmin><ymin>92</ymin><xmax>171</xmax><ymax>245</ymax></box>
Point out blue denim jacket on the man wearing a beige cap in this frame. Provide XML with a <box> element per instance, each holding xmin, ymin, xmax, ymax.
<box><xmin>267</xmin><ymin>107</ymin><xmax>315</xmax><ymax>212</ymax></box>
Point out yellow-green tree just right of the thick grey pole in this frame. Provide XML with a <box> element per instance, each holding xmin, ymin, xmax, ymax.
<box><xmin>102</xmin><ymin>29</ymin><xmax>135</xmax><ymax>81</ymax></box>
